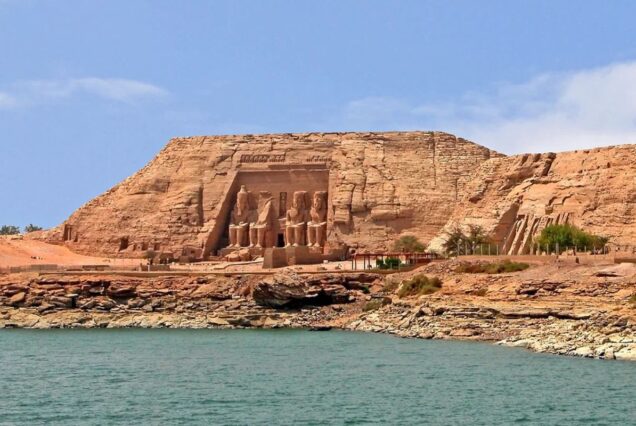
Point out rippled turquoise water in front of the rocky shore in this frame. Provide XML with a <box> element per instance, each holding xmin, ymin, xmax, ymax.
<box><xmin>0</xmin><ymin>330</ymin><xmax>636</xmax><ymax>425</ymax></box>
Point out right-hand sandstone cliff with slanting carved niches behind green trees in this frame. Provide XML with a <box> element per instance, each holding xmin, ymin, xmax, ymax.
<box><xmin>431</xmin><ymin>145</ymin><xmax>636</xmax><ymax>254</ymax></box>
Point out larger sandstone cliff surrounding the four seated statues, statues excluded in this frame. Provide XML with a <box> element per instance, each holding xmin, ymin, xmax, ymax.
<box><xmin>42</xmin><ymin>132</ymin><xmax>501</xmax><ymax>258</ymax></box>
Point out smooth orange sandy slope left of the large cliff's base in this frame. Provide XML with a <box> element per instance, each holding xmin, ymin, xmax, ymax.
<box><xmin>0</xmin><ymin>237</ymin><xmax>139</xmax><ymax>268</ymax></box>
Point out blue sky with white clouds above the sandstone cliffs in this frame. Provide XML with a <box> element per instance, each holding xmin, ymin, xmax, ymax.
<box><xmin>0</xmin><ymin>0</ymin><xmax>636</xmax><ymax>227</ymax></box>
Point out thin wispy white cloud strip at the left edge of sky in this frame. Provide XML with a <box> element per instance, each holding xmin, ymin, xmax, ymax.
<box><xmin>0</xmin><ymin>77</ymin><xmax>168</xmax><ymax>109</ymax></box>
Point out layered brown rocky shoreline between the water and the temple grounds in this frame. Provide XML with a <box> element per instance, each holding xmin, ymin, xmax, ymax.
<box><xmin>0</xmin><ymin>262</ymin><xmax>636</xmax><ymax>360</ymax></box>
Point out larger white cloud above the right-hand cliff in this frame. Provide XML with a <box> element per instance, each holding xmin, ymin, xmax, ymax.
<box><xmin>343</xmin><ymin>62</ymin><xmax>636</xmax><ymax>154</ymax></box>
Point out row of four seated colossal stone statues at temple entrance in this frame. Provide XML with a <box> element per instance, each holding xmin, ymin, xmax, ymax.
<box><xmin>229</xmin><ymin>185</ymin><xmax>327</xmax><ymax>248</ymax></box>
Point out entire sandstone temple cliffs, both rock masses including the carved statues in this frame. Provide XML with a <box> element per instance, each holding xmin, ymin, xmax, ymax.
<box><xmin>43</xmin><ymin>132</ymin><xmax>636</xmax><ymax>265</ymax></box>
